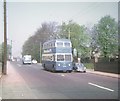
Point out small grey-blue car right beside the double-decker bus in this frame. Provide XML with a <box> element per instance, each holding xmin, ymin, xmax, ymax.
<box><xmin>73</xmin><ymin>63</ymin><xmax>86</xmax><ymax>73</ymax></box>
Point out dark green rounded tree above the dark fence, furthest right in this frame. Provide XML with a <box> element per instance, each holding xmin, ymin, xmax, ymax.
<box><xmin>96</xmin><ymin>15</ymin><xmax>118</xmax><ymax>57</ymax></box>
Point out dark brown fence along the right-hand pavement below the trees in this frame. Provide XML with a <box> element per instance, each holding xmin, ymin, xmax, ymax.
<box><xmin>81</xmin><ymin>58</ymin><xmax>120</xmax><ymax>74</ymax></box>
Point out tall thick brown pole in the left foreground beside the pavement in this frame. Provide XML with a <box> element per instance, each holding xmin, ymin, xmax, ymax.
<box><xmin>2</xmin><ymin>0</ymin><xmax>7</xmax><ymax>75</ymax></box>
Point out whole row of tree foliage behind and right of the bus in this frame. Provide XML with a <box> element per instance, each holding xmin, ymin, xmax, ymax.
<box><xmin>22</xmin><ymin>16</ymin><xmax>118</xmax><ymax>61</ymax></box>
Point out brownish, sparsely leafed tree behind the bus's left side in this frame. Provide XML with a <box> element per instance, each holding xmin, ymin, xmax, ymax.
<box><xmin>22</xmin><ymin>22</ymin><xmax>59</xmax><ymax>62</ymax></box>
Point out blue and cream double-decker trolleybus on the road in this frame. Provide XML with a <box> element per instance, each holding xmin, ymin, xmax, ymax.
<box><xmin>42</xmin><ymin>39</ymin><xmax>73</xmax><ymax>72</ymax></box>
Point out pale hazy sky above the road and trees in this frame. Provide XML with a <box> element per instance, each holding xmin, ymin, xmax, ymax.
<box><xmin>0</xmin><ymin>0</ymin><xmax>118</xmax><ymax>56</ymax></box>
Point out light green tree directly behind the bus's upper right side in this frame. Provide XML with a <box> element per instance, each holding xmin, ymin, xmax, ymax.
<box><xmin>60</xmin><ymin>21</ymin><xmax>90</xmax><ymax>57</ymax></box>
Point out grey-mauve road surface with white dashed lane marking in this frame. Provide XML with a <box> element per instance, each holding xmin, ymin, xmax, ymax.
<box><xmin>11</xmin><ymin>62</ymin><xmax>118</xmax><ymax>99</ymax></box>
